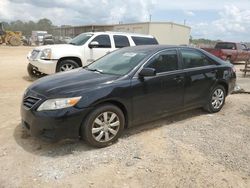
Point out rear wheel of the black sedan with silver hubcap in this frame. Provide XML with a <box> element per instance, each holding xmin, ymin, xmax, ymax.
<box><xmin>205</xmin><ymin>85</ymin><xmax>226</xmax><ymax>113</ymax></box>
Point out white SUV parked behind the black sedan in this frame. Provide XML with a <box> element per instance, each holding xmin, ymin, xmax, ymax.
<box><xmin>27</xmin><ymin>32</ymin><xmax>158</xmax><ymax>77</ymax></box>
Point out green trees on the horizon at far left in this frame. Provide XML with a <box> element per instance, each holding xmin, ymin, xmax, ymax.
<box><xmin>3</xmin><ymin>18</ymin><xmax>55</xmax><ymax>37</ymax></box>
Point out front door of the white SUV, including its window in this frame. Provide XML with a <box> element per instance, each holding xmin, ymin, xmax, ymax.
<box><xmin>85</xmin><ymin>34</ymin><xmax>115</xmax><ymax>64</ymax></box>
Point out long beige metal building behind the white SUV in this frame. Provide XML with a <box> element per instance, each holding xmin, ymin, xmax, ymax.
<box><xmin>56</xmin><ymin>22</ymin><xmax>191</xmax><ymax>45</ymax></box>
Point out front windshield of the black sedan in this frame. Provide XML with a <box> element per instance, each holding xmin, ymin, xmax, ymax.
<box><xmin>86</xmin><ymin>50</ymin><xmax>148</xmax><ymax>76</ymax></box>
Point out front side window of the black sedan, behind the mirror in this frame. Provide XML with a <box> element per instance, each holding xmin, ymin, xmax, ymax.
<box><xmin>148</xmin><ymin>50</ymin><xmax>178</xmax><ymax>73</ymax></box>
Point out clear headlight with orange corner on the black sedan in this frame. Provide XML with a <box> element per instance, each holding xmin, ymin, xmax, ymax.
<box><xmin>37</xmin><ymin>97</ymin><xmax>82</xmax><ymax>111</ymax></box>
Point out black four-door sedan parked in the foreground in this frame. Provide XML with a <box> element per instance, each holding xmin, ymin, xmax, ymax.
<box><xmin>21</xmin><ymin>45</ymin><xmax>236</xmax><ymax>147</ymax></box>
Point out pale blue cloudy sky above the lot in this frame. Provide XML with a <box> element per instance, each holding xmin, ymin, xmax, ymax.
<box><xmin>0</xmin><ymin>0</ymin><xmax>250</xmax><ymax>42</ymax></box>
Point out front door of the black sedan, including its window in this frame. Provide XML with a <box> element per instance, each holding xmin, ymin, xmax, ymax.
<box><xmin>131</xmin><ymin>50</ymin><xmax>184</xmax><ymax>124</ymax></box>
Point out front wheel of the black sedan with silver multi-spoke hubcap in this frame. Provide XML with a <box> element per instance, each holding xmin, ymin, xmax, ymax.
<box><xmin>81</xmin><ymin>104</ymin><xmax>125</xmax><ymax>147</ymax></box>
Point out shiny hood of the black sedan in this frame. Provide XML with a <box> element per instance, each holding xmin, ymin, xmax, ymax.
<box><xmin>28</xmin><ymin>68</ymin><xmax>119</xmax><ymax>97</ymax></box>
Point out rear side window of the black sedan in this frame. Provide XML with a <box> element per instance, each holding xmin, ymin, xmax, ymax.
<box><xmin>181</xmin><ymin>50</ymin><xmax>215</xmax><ymax>68</ymax></box>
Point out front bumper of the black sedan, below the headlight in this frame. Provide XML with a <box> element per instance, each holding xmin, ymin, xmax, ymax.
<box><xmin>21</xmin><ymin>105</ymin><xmax>91</xmax><ymax>140</ymax></box>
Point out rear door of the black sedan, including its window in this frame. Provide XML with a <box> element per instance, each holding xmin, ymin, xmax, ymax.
<box><xmin>180</xmin><ymin>49</ymin><xmax>217</xmax><ymax>107</ymax></box>
